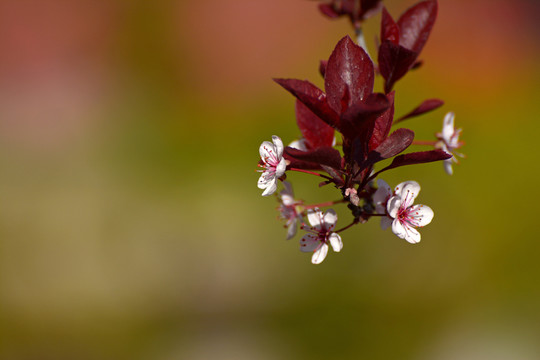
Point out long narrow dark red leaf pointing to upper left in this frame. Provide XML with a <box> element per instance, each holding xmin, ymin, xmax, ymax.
<box><xmin>274</xmin><ymin>79</ymin><xmax>339</xmax><ymax>127</ymax></box>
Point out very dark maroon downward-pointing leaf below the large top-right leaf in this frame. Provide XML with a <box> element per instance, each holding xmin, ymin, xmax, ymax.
<box><xmin>379</xmin><ymin>40</ymin><xmax>418</xmax><ymax>94</ymax></box>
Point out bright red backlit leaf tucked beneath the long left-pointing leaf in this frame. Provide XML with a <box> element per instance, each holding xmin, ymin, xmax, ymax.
<box><xmin>296</xmin><ymin>100</ymin><xmax>334</xmax><ymax>149</ymax></box>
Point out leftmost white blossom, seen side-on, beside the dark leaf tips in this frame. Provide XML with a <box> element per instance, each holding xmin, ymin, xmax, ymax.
<box><xmin>257</xmin><ymin>135</ymin><xmax>287</xmax><ymax>196</ymax></box>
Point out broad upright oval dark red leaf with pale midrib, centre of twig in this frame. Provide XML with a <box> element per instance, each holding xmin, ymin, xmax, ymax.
<box><xmin>324</xmin><ymin>36</ymin><xmax>375</xmax><ymax>114</ymax></box>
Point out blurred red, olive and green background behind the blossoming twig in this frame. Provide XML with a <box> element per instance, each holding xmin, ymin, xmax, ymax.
<box><xmin>0</xmin><ymin>0</ymin><xmax>540</xmax><ymax>360</ymax></box>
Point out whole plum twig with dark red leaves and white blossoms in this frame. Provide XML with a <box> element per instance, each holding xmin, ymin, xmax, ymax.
<box><xmin>257</xmin><ymin>0</ymin><xmax>463</xmax><ymax>264</ymax></box>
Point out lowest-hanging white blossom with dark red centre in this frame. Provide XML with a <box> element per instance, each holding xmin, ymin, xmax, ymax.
<box><xmin>300</xmin><ymin>208</ymin><xmax>343</xmax><ymax>264</ymax></box>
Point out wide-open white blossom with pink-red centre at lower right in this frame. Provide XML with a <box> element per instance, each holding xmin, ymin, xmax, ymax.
<box><xmin>386</xmin><ymin>181</ymin><xmax>433</xmax><ymax>244</ymax></box>
